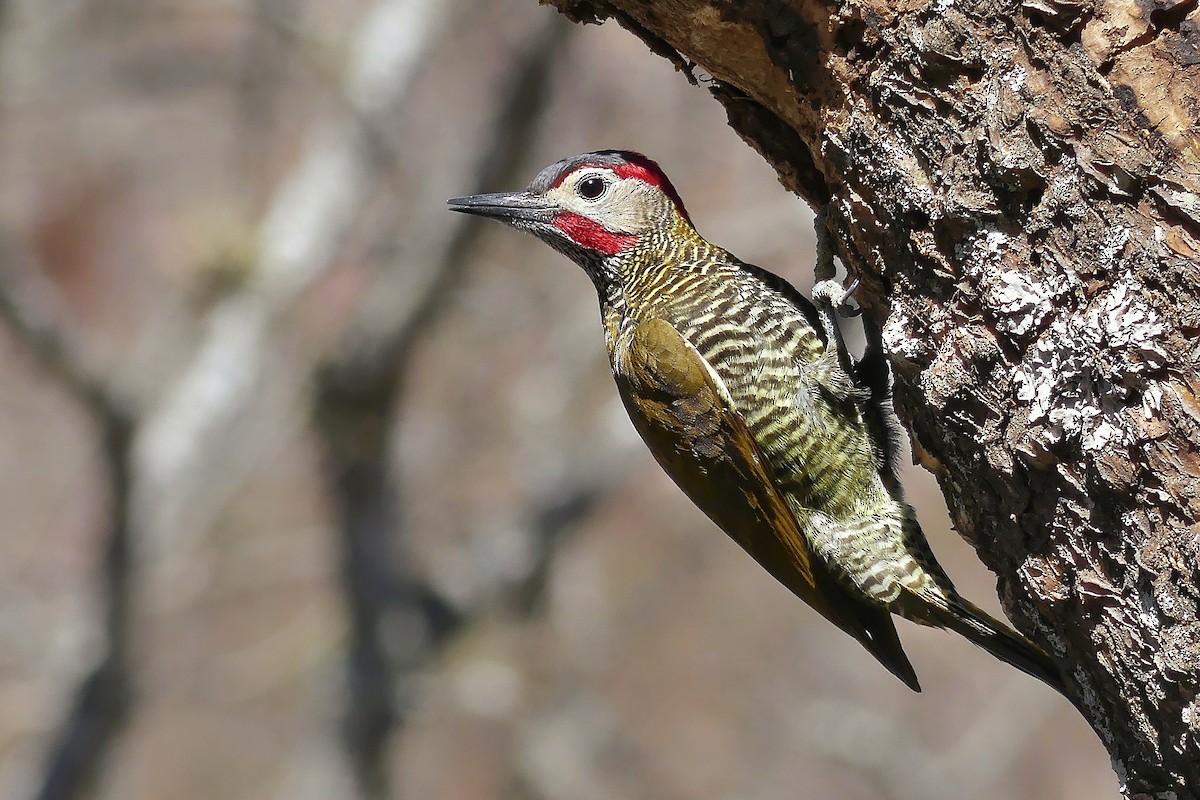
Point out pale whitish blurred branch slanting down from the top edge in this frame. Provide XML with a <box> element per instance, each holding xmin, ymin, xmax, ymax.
<box><xmin>129</xmin><ymin>0</ymin><xmax>454</xmax><ymax>563</ymax></box>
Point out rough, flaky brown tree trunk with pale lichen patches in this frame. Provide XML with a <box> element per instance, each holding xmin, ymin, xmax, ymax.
<box><xmin>544</xmin><ymin>0</ymin><xmax>1200</xmax><ymax>798</ymax></box>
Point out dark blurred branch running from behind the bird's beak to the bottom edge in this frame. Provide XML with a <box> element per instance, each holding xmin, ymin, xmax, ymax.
<box><xmin>314</xmin><ymin>20</ymin><xmax>566</xmax><ymax>798</ymax></box>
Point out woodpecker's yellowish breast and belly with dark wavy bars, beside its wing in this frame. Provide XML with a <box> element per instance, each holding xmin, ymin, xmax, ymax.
<box><xmin>629</xmin><ymin>254</ymin><xmax>931</xmax><ymax>604</ymax></box>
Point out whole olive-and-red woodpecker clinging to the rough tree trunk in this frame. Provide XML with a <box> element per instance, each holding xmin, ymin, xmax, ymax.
<box><xmin>449</xmin><ymin>150</ymin><xmax>1062</xmax><ymax>691</ymax></box>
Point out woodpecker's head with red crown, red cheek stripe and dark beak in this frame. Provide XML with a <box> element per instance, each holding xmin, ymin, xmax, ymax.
<box><xmin>449</xmin><ymin>150</ymin><xmax>691</xmax><ymax>278</ymax></box>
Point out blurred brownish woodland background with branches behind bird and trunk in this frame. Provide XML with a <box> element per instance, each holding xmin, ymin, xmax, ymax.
<box><xmin>0</xmin><ymin>0</ymin><xmax>1116</xmax><ymax>800</ymax></box>
